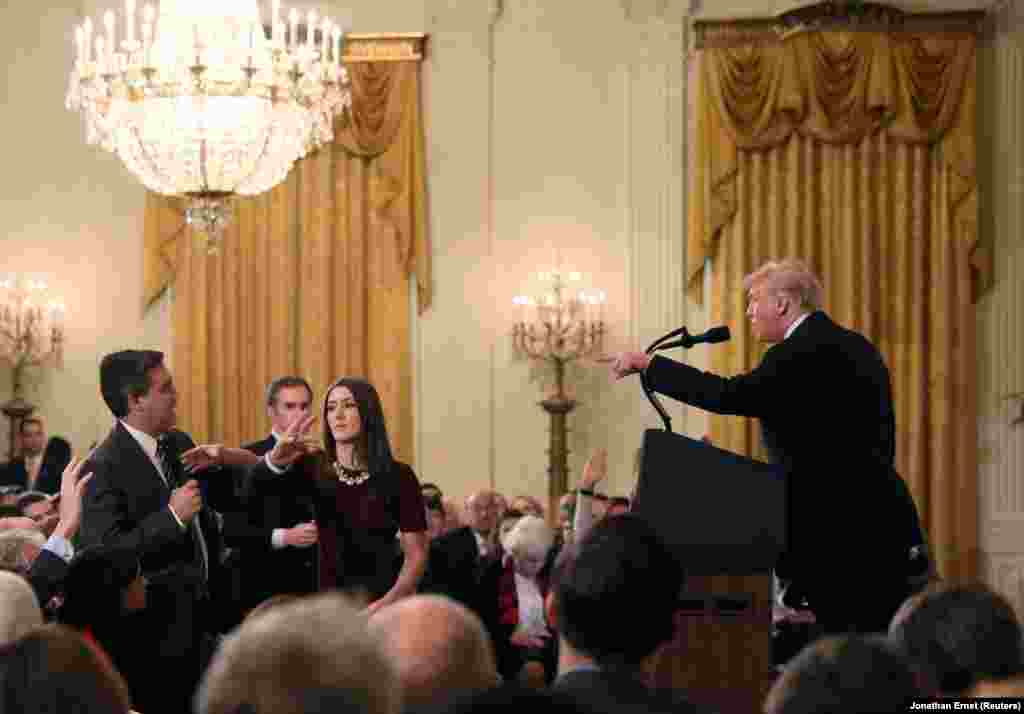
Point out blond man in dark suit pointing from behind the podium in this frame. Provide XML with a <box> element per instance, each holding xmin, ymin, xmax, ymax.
<box><xmin>608</xmin><ymin>260</ymin><xmax>913</xmax><ymax>632</ymax></box>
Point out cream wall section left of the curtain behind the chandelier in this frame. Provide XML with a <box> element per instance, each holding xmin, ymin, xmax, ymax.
<box><xmin>0</xmin><ymin>2</ymin><xmax>170</xmax><ymax>458</ymax></box>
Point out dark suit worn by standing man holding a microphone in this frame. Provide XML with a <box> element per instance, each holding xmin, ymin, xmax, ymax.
<box><xmin>79</xmin><ymin>422</ymin><xmax>232</xmax><ymax>712</ymax></box>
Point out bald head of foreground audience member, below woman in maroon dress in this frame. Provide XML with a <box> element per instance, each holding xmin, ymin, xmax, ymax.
<box><xmin>370</xmin><ymin>595</ymin><xmax>500</xmax><ymax>713</ymax></box>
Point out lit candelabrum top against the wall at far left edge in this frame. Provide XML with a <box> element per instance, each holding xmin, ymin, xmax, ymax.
<box><xmin>0</xmin><ymin>278</ymin><xmax>63</xmax><ymax>401</ymax></box>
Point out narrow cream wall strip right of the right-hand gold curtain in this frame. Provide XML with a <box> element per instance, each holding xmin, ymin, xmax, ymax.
<box><xmin>978</xmin><ymin>2</ymin><xmax>1024</xmax><ymax>613</ymax></box>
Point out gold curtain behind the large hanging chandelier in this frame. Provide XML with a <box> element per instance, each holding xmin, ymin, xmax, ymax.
<box><xmin>144</xmin><ymin>61</ymin><xmax>431</xmax><ymax>461</ymax></box>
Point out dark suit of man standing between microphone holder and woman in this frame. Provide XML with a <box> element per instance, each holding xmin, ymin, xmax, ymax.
<box><xmin>231</xmin><ymin>434</ymin><xmax>316</xmax><ymax>610</ymax></box>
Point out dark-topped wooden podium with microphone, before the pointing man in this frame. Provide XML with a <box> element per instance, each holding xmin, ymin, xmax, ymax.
<box><xmin>632</xmin><ymin>429</ymin><xmax>786</xmax><ymax>714</ymax></box>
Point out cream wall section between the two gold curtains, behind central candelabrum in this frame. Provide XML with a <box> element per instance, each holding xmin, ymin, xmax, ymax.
<box><xmin>407</xmin><ymin>0</ymin><xmax>693</xmax><ymax>506</ymax></box>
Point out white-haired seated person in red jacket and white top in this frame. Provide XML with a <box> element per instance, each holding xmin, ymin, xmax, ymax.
<box><xmin>497</xmin><ymin>515</ymin><xmax>557</xmax><ymax>688</ymax></box>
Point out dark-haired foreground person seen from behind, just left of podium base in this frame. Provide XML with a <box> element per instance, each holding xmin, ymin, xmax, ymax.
<box><xmin>545</xmin><ymin>515</ymin><xmax>698</xmax><ymax>713</ymax></box>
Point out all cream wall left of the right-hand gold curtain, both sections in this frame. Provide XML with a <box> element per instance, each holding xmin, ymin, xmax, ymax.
<box><xmin>0</xmin><ymin>0</ymin><xmax>703</xmax><ymax>504</ymax></box>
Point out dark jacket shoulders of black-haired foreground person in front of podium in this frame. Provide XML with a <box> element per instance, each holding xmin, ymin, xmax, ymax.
<box><xmin>551</xmin><ymin>670</ymin><xmax>702</xmax><ymax>714</ymax></box>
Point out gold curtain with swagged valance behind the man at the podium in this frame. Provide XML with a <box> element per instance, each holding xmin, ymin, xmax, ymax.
<box><xmin>687</xmin><ymin>31</ymin><xmax>984</xmax><ymax>579</ymax></box>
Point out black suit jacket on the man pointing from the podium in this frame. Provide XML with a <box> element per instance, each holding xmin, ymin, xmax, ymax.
<box><xmin>644</xmin><ymin>311</ymin><xmax>907</xmax><ymax>618</ymax></box>
